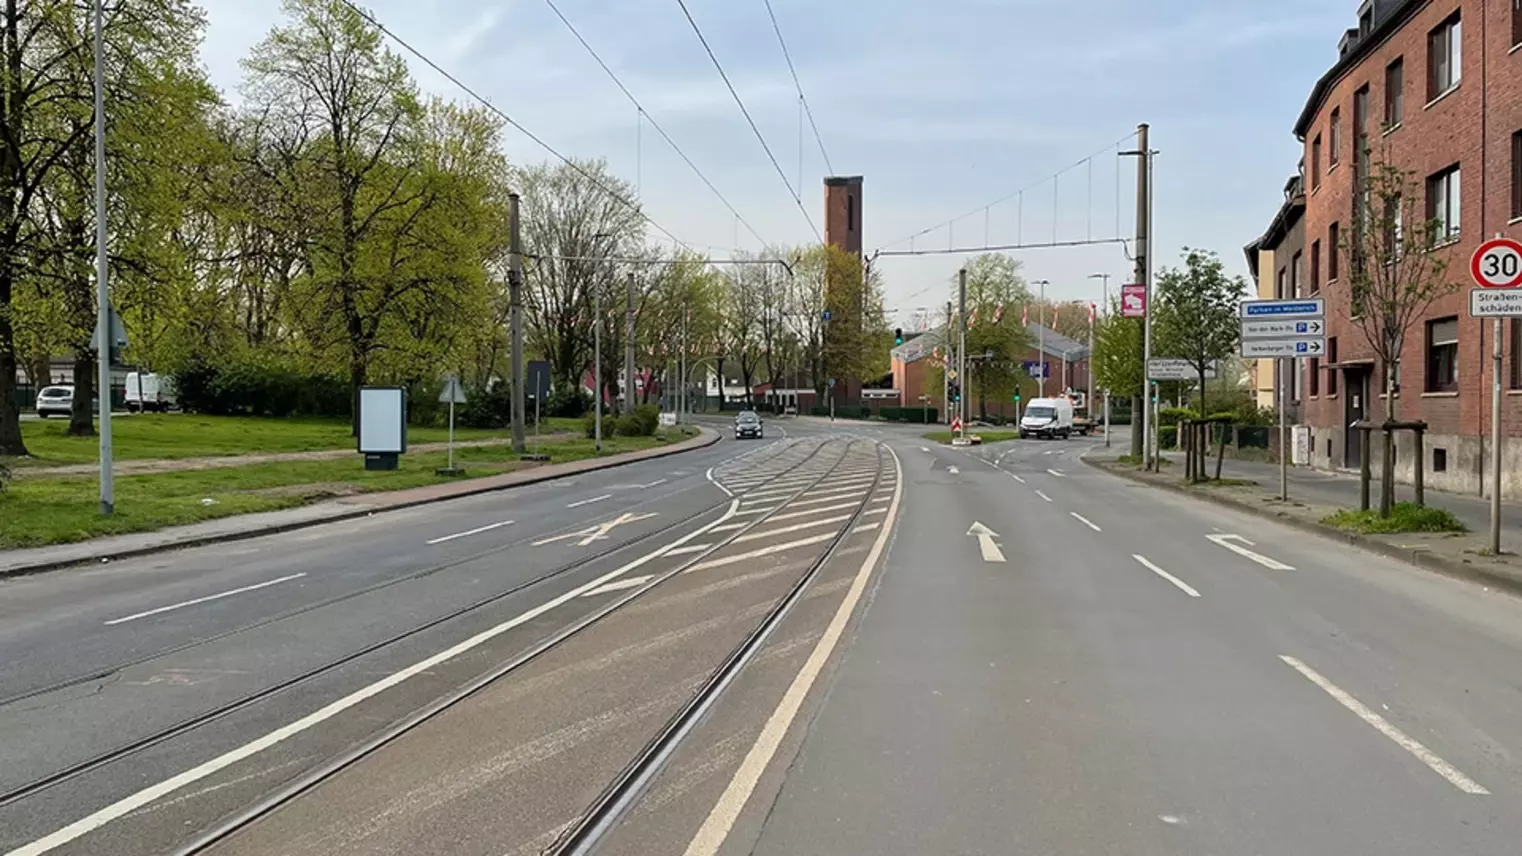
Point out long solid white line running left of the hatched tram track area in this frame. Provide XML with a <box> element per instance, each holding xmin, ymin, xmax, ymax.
<box><xmin>6</xmin><ymin>504</ymin><xmax>735</xmax><ymax>856</ymax></box>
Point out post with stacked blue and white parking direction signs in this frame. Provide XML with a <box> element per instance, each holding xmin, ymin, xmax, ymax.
<box><xmin>1240</xmin><ymin>297</ymin><xmax>1327</xmax><ymax>503</ymax></box>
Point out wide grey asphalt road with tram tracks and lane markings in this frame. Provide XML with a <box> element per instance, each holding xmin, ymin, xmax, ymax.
<box><xmin>14</xmin><ymin>419</ymin><xmax>1522</xmax><ymax>856</ymax></box>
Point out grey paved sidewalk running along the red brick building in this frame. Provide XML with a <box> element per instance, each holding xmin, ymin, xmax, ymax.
<box><xmin>1163</xmin><ymin>449</ymin><xmax>1522</xmax><ymax>539</ymax></box>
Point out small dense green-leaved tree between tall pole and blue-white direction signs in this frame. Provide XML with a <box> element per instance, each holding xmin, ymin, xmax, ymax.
<box><xmin>1152</xmin><ymin>247</ymin><xmax>1247</xmax><ymax>417</ymax></box>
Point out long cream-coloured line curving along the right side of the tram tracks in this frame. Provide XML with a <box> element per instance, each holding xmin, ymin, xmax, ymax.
<box><xmin>685</xmin><ymin>446</ymin><xmax>903</xmax><ymax>856</ymax></box>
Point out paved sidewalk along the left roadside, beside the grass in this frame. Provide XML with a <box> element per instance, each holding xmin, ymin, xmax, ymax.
<box><xmin>0</xmin><ymin>428</ymin><xmax>718</xmax><ymax>579</ymax></box>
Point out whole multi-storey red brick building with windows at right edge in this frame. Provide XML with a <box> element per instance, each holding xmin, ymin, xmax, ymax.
<box><xmin>1294</xmin><ymin>0</ymin><xmax>1522</xmax><ymax>497</ymax></box>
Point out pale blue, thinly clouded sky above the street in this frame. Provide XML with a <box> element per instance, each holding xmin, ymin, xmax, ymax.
<box><xmin>201</xmin><ymin>0</ymin><xmax>1358</xmax><ymax>326</ymax></box>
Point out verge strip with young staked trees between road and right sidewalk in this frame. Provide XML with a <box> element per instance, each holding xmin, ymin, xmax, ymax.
<box><xmin>1082</xmin><ymin>457</ymin><xmax>1522</xmax><ymax>594</ymax></box>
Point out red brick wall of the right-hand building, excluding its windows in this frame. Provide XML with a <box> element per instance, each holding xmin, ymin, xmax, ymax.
<box><xmin>1297</xmin><ymin>0</ymin><xmax>1522</xmax><ymax>489</ymax></box>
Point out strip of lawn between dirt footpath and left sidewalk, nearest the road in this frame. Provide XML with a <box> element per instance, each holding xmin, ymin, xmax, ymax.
<box><xmin>0</xmin><ymin>426</ymin><xmax>700</xmax><ymax>548</ymax></box>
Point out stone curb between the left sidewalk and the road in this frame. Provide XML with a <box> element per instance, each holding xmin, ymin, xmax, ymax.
<box><xmin>0</xmin><ymin>428</ymin><xmax>721</xmax><ymax>580</ymax></box>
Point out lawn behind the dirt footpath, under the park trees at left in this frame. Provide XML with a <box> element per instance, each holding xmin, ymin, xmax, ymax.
<box><xmin>8</xmin><ymin>413</ymin><xmax>581</xmax><ymax>466</ymax></box>
